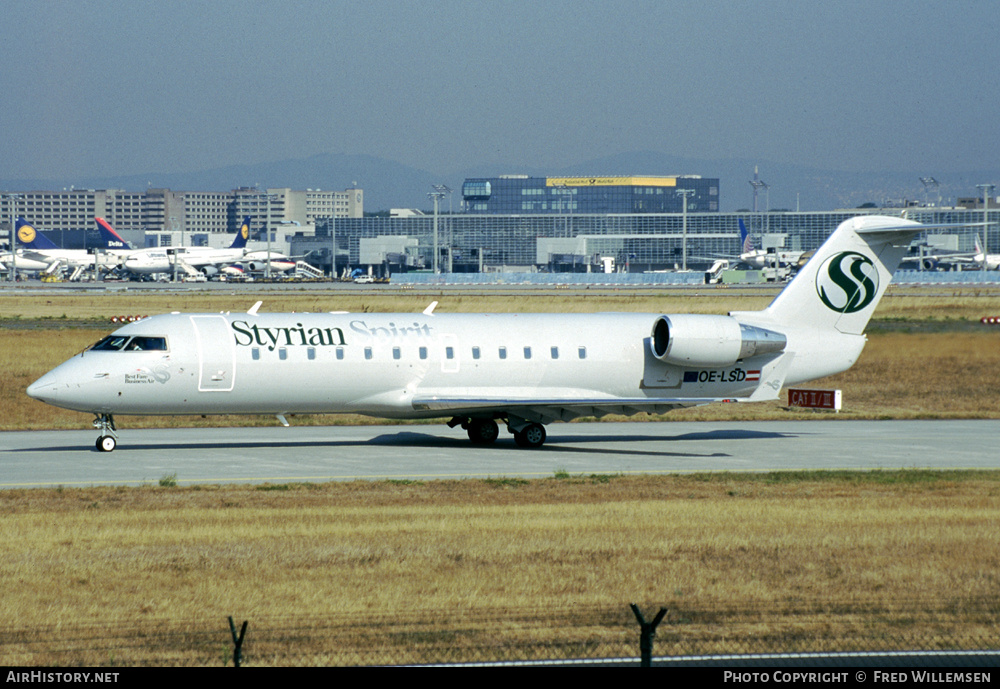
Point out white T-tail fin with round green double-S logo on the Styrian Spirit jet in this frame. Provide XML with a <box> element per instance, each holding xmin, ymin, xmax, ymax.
<box><xmin>733</xmin><ymin>215</ymin><xmax>927</xmax><ymax>335</ymax></box>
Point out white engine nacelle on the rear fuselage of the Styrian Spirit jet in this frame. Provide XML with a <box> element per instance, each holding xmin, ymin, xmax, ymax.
<box><xmin>649</xmin><ymin>314</ymin><xmax>786</xmax><ymax>367</ymax></box>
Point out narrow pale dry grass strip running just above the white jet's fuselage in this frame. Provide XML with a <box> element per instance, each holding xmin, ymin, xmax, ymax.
<box><xmin>0</xmin><ymin>285</ymin><xmax>1000</xmax><ymax>323</ymax></box>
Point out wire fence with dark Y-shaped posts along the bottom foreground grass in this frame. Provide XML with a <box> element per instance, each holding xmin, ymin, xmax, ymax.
<box><xmin>0</xmin><ymin>601</ymin><xmax>1000</xmax><ymax>667</ymax></box>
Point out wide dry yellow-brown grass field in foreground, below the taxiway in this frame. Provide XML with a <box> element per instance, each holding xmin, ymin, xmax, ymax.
<box><xmin>0</xmin><ymin>472</ymin><xmax>1000</xmax><ymax>664</ymax></box>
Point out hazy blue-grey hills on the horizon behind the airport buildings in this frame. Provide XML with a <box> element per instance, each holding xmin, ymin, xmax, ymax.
<box><xmin>0</xmin><ymin>151</ymin><xmax>1000</xmax><ymax>212</ymax></box>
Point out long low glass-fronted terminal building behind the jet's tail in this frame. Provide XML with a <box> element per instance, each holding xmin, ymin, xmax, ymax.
<box><xmin>298</xmin><ymin>208</ymin><xmax>1000</xmax><ymax>275</ymax></box>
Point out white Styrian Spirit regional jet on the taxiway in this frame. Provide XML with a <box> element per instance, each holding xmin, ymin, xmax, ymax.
<box><xmin>27</xmin><ymin>216</ymin><xmax>926</xmax><ymax>452</ymax></box>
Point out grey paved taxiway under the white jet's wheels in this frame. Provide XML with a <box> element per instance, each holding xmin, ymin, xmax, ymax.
<box><xmin>0</xmin><ymin>419</ymin><xmax>1000</xmax><ymax>488</ymax></box>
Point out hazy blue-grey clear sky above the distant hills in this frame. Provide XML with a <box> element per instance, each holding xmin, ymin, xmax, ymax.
<box><xmin>0</xmin><ymin>0</ymin><xmax>1000</xmax><ymax>179</ymax></box>
